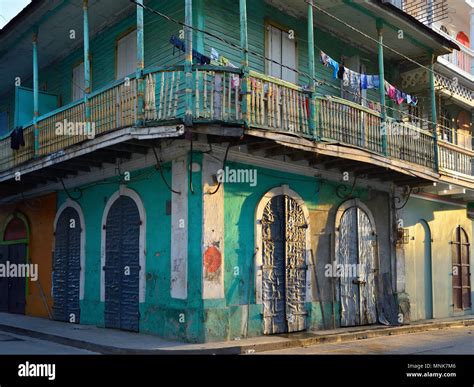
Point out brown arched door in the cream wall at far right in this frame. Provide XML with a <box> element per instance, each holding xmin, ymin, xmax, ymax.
<box><xmin>451</xmin><ymin>226</ymin><xmax>471</xmax><ymax>311</ymax></box>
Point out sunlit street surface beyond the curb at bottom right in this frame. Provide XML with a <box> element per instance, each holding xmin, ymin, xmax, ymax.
<box><xmin>259</xmin><ymin>326</ymin><xmax>474</xmax><ymax>355</ymax></box>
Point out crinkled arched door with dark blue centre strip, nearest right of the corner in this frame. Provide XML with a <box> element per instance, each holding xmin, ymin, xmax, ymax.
<box><xmin>262</xmin><ymin>195</ymin><xmax>308</xmax><ymax>334</ymax></box>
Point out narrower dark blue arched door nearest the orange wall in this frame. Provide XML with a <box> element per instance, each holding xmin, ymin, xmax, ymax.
<box><xmin>53</xmin><ymin>207</ymin><xmax>82</xmax><ymax>323</ymax></box>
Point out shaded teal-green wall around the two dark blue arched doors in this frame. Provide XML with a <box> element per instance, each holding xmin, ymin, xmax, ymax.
<box><xmin>58</xmin><ymin>162</ymin><xmax>202</xmax><ymax>342</ymax></box>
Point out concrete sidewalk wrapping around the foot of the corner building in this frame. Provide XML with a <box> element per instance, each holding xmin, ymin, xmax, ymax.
<box><xmin>0</xmin><ymin>313</ymin><xmax>474</xmax><ymax>355</ymax></box>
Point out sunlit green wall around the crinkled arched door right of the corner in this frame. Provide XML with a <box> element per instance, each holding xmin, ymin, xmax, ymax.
<box><xmin>204</xmin><ymin>162</ymin><xmax>368</xmax><ymax>341</ymax></box>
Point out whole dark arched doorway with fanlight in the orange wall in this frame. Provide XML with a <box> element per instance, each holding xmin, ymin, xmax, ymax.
<box><xmin>0</xmin><ymin>213</ymin><xmax>29</xmax><ymax>314</ymax></box>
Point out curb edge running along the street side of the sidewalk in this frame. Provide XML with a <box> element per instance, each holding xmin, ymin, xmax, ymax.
<box><xmin>0</xmin><ymin>318</ymin><xmax>474</xmax><ymax>355</ymax></box>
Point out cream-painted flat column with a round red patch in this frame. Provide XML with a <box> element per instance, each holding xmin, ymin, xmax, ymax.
<box><xmin>202</xmin><ymin>154</ymin><xmax>224</xmax><ymax>299</ymax></box>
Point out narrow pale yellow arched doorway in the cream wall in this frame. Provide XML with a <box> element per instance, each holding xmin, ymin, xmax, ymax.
<box><xmin>413</xmin><ymin>220</ymin><xmax>433</xmax><ymax>320</ymax></box>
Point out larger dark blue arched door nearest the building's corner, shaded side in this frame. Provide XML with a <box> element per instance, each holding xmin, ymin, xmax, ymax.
<box><xmin>104</xmin><ymin>196</ymin><xmax>141</xmax><ymax>332</ymax></box>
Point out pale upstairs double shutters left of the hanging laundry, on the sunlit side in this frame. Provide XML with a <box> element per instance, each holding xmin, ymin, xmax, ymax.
<box><xmin>266</xmin><ymin>24</ymin><xmax>298</xmax><ymax>84</ymax></box>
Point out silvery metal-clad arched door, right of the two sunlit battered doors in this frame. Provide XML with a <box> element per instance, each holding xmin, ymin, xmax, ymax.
<box><xmin>336</xmin><ymin>207</ymin><xmax>377</xmax><ymax>326</ymax></box>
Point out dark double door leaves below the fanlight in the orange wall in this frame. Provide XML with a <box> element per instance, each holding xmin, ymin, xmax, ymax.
<box><xmin>0</xmin><ymin>243</ymin><xmax>26</xmax><ymax>314</ymax></box>
